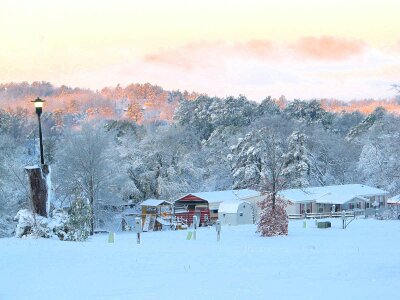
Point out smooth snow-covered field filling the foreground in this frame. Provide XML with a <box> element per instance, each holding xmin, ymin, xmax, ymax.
<box><xmin>0</xmin><ymin>219</ymin><xmax>400</xmax><ymax>300</ymax></box>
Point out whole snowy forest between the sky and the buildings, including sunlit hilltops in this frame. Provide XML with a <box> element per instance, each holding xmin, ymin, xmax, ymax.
<box><xmin>0</xmin><ymin>82</ymin><xmax>400</xmax><ymax>236</ymax></box>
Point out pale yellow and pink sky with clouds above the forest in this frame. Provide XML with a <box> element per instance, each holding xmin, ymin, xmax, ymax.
<box><xmin>0</xmin><ymin>0</ymin><xmax>400</xmax><ymax>101</ymax></box>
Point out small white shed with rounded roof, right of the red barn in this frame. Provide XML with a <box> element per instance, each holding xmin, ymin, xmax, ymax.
<box><xmin>218</xmin><ymin>201</ymin><xmax>253</xmax><ymax>225</ymax></box>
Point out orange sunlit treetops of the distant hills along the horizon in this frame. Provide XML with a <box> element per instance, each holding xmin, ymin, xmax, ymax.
<box><xmin>0</xmin><ymin>82</ymin><xmax>400</xmax><ymax>123</ymax></box>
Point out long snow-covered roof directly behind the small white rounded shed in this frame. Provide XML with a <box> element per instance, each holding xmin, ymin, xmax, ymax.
<box><xmin>181</xmin><ymin>189</ymin><xmax>261</xmax><ymax>203</ymax></box>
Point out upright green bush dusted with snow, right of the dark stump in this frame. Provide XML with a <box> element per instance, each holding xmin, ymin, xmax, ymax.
<box><xmin>66</xmin><ymin>198</ymin><xmax>92</xmax><ymax>241</ymax></box>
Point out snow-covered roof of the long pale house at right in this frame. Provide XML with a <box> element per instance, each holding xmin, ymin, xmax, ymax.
<box><xmin>279</xmin><ymin>184</ymin><xmax>389</xmax><ymax>204</ymax></box>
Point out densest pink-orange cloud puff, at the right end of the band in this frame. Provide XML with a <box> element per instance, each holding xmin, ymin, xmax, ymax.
<box><xmin>290</xmin><ymin>36</ymin><xmax>366</xmax><ymax>60</ymax></box>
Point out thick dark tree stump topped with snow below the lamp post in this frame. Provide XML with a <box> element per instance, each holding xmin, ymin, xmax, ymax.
<box><xmin>25</xmin><ymin>165</ymin><xmax>49</xmax><ymax>217</ymax></box>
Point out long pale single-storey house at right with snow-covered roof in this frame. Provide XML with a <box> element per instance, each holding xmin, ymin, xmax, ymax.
<box><xmin>279</xmin><ymin>184</ymin><xmax>389</xmax><ymax>214</ymax></box>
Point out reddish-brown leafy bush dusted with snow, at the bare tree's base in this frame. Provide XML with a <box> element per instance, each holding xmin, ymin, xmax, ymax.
<box><xmin>257</xmin><ymin>194</ymin><xmax>289</xmax><ymax>236</ymax></box>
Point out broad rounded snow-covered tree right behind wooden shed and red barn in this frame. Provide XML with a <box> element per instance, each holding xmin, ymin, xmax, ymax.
<box><xmin>124</xmin><ymin>127</ymin><xmax>202</xmax><ymax>200</ymax></box>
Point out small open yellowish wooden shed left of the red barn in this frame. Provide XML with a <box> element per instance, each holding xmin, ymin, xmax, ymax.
<box><xmin>140</xmin><ymin>199</ymin><xmax>173</xmax><ymax>231</ymax></box>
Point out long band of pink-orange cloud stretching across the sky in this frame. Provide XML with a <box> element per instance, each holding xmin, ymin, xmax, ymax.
<box><xmin>144</xmin><ymin>36</ymin><xmax>367</xmax><ymax>71</ymax></box>
